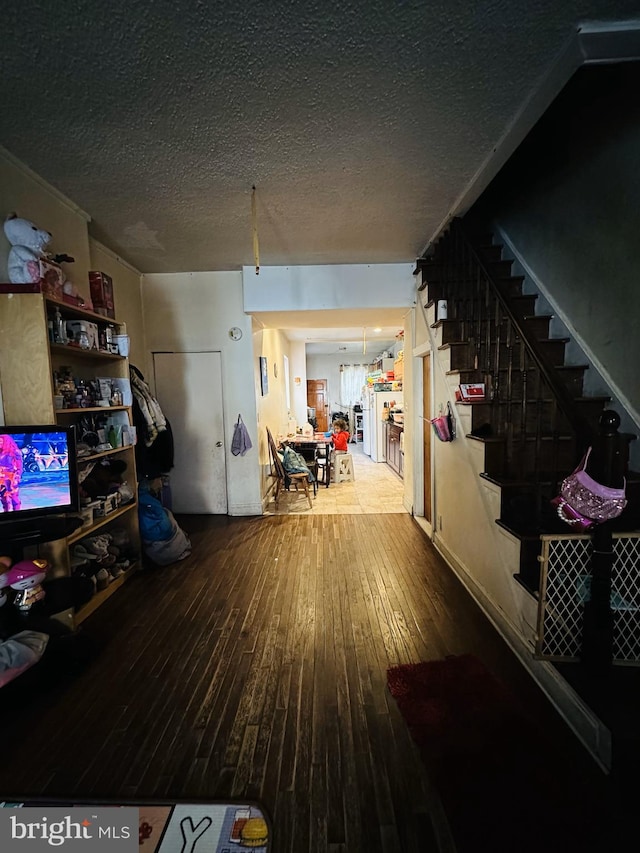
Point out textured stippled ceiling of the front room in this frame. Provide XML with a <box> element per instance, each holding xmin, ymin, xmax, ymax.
<box><xmin>0</xmin><ymin>0</ymin><xmax>637</xmax><ymax>350</ymax></box>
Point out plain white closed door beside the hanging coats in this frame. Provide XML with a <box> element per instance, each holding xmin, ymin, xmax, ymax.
<box><xmin>153</xmin><ymin>352</ymin><xmax>227</xmax><ymax>515</ymax></box>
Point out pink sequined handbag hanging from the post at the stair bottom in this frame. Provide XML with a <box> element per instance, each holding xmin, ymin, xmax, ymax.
<box><xmin>551</xmin><ymin>448</ymin><xmax>627</xmax><ymax>531</ymax></box>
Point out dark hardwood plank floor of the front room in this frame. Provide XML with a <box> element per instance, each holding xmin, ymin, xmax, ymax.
<box><xmin>0</xmin><ymin>510</ymin><xmax>612</xmax><ymax>853</ymax></box>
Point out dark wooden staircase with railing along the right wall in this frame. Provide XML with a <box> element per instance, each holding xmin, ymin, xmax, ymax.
<box><xmin>417</xmin><ymin>220</ymin><xmax>640</xmax><ymax>595</ymax></box>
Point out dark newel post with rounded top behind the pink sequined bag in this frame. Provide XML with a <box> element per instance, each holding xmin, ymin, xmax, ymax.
<box><xmin>581</xmin><ymin>409</ymin><xmax>629</xmax><ymax>675</ymax></box>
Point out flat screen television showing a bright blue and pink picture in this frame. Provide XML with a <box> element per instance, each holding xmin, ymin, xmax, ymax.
<box><xmin>0</xmin><ymin>424</ymin><xmax>79</xmax><ymax>542</ymax></box>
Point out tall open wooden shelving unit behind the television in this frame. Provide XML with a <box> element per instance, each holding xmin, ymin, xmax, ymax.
<box><xmin>0</xmin><ymin>292</ymin><xmax>140</xmax><ymax>623</ymax></box>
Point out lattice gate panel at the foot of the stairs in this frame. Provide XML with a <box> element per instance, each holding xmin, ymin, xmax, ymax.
<box><xmin>536</xmin><ymin>534</ymin><xmax>640</xmax><ymax>664</ymax></box>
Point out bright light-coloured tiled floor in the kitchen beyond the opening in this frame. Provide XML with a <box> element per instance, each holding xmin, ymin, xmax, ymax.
<box><xmin>267</xmin><ymin>444</ymin><xmax>406</xmax><ymax>515</ymax></box>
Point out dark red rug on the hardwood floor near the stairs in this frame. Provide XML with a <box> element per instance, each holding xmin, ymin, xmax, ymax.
<box><xmin>387</xmin><ymin>655</ymin><xmax>613</xmax><ymax>853</ymax></box>
